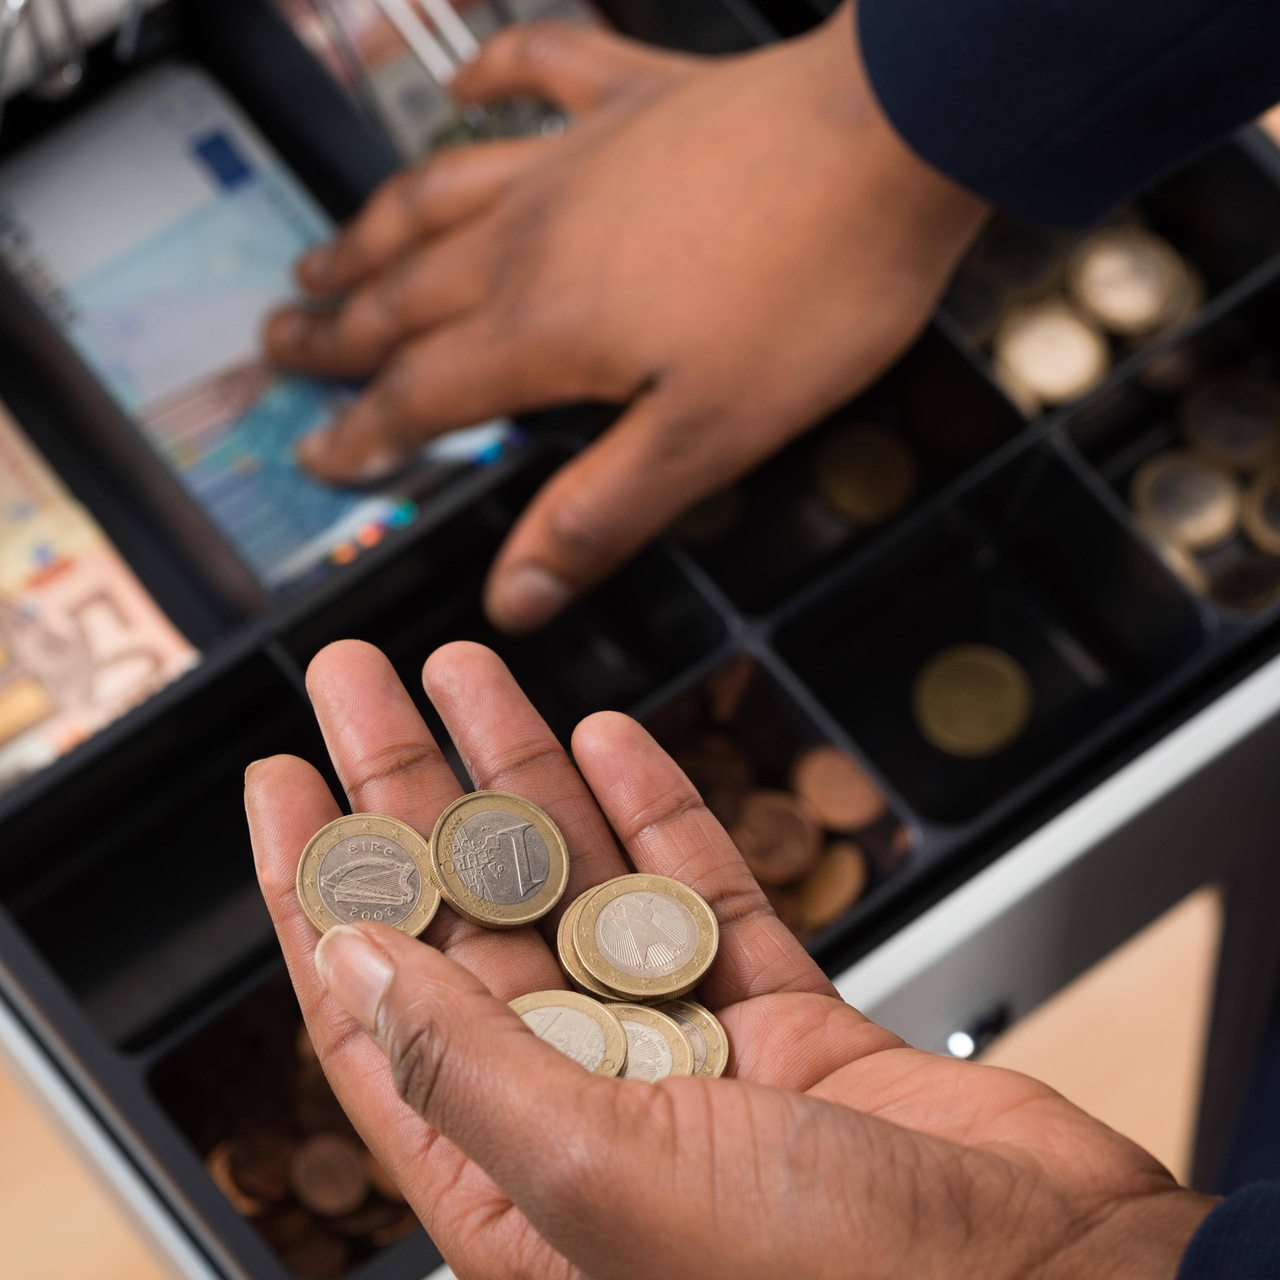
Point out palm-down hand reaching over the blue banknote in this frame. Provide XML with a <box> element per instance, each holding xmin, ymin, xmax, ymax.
<box><xmin>268</xmin><ymin>5</ymin><xmax>984</xmax><ymax>630</ymax></box>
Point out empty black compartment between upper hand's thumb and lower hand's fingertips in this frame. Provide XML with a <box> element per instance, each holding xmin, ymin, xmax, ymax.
<box><xmin>283</xmin><ymin>454</ymin><xmax>724</xmax><ymax>737</ymax></box>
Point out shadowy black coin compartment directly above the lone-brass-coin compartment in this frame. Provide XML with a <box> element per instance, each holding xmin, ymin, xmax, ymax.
<box><xmin>673</xmin><ymin>329</ymin><xmax>1023</xmax><ymax>614</ymax></box>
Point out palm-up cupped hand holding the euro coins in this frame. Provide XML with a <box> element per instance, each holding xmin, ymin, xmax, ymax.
<box><xmin>247</xmin><ymin>641</ymin><xmax>1211</xmax><ymax>1280</ymax></box>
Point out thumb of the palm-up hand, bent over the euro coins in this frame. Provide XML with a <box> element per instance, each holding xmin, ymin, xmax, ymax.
<box><xmin>315</xmin><ymin>924</ymin><xmax>634</xmax><ymax>1220</ymax></box>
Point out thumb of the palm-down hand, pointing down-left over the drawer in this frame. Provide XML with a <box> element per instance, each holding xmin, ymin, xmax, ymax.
<box><xmin>485</xmin><ymin>388</ymin><xmax>732</xmax><ymax>632</ymax></box>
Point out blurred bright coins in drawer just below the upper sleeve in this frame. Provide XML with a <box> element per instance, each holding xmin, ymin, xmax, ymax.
<box><xmin>943</xmin><ymin>218</ymin><xmax>1204</xmax><ymax>417</ymax></box>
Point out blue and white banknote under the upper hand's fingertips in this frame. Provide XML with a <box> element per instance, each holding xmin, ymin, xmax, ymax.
<box><xmin>0</xmin><ymin>64</ymin><xmax>511</xmax><ymax>590</ymax></box>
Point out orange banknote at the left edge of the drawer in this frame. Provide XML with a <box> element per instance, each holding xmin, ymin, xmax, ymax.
<box><xmin>0</xmin><ymin>404</ymin><xmax>197</xmax><ymax>790</ymax></box>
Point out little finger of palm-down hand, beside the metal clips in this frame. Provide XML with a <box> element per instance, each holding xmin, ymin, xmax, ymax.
<box><xmin>451</xmin><ymin>22</ymin><xmax>694</xmax><ymax>115</ymax></box>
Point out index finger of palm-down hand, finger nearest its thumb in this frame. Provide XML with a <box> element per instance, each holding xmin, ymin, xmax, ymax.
<box><xmin>297</xmin><ymin>317</ymin><xmax>553</xmax><ymax>484</ymax></box>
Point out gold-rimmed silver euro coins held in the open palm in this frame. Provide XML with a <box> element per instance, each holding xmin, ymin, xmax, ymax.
<box><xmin>297</xmin><ymin>791</ymin><xmax>728</xmax><ymax>1080</ymax></box>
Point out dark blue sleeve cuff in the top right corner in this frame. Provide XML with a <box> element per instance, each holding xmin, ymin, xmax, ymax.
<box><xmin>858</xmin><ymin>0</ymin><xmax>1280</xmax><ymax>225</ymax></box>
